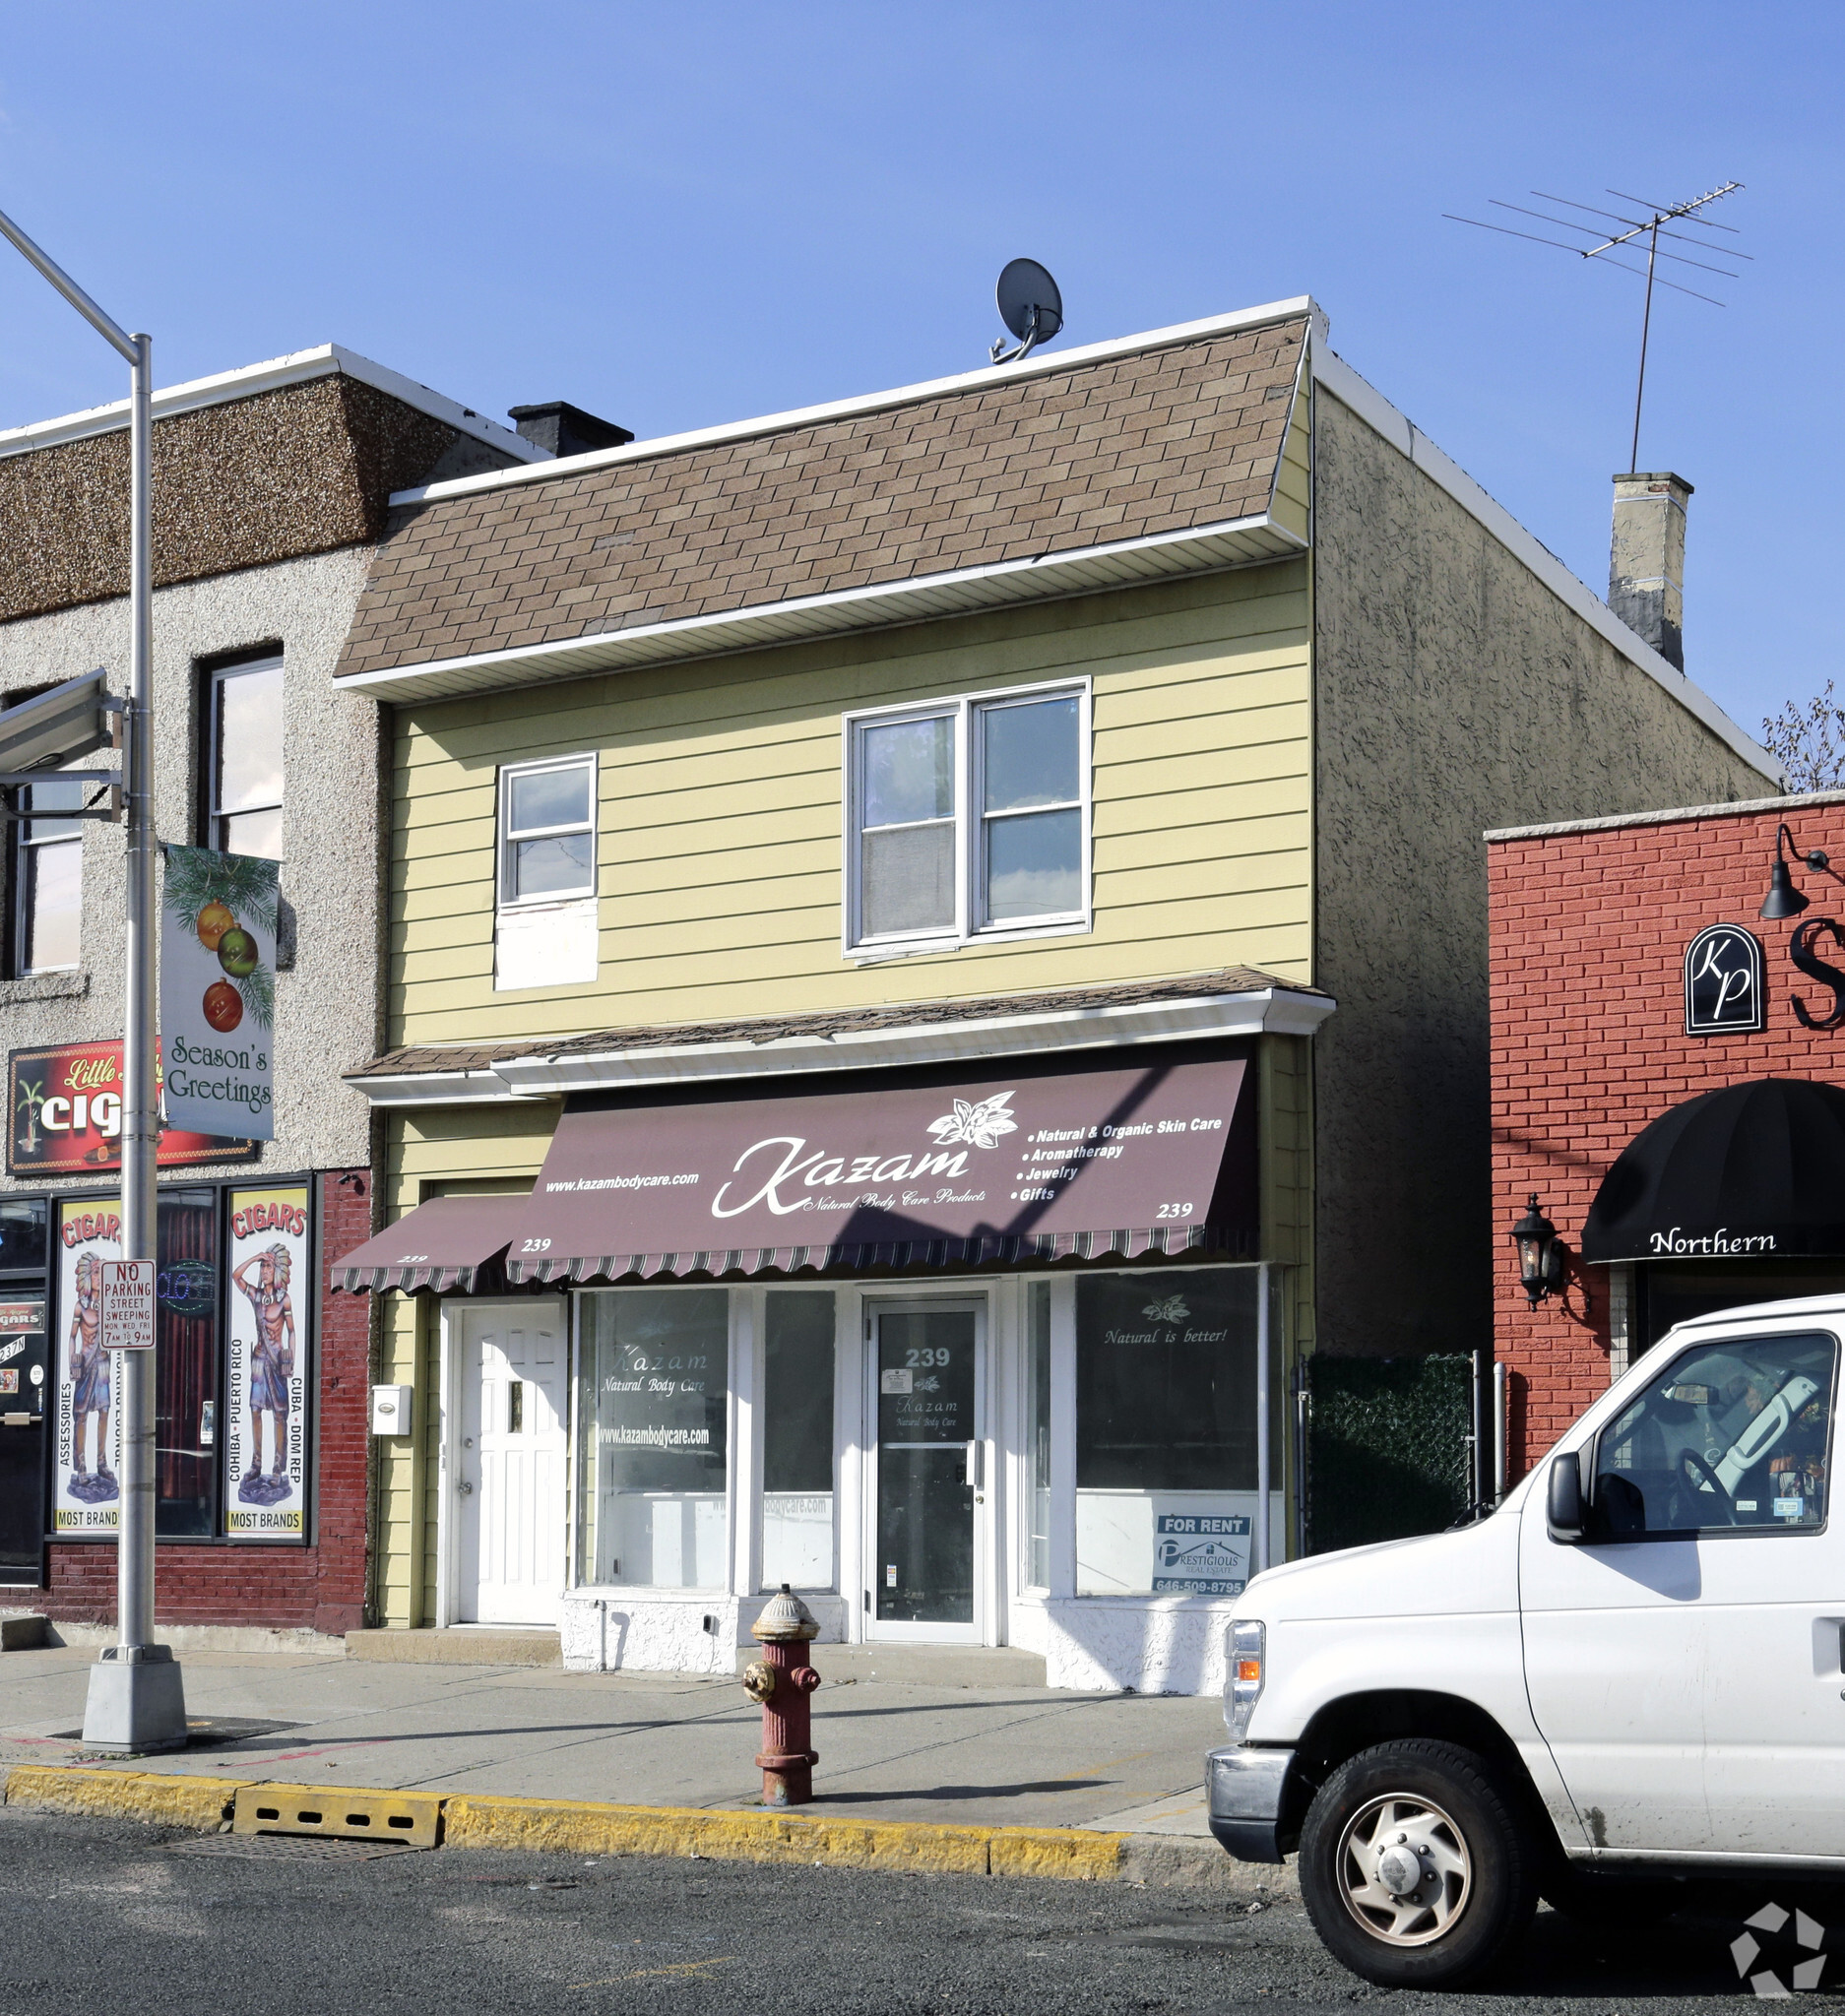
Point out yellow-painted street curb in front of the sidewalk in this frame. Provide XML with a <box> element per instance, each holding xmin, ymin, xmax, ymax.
<box><xmin>6</xmin><ymin>1764</ymin><xmax>1299</xmax><ymax>1901</ymax></box>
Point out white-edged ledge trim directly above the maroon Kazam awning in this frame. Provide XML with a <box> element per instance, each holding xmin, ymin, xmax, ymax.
<box><xmin>347</xmin><ymin>985</ymin><xmax>1337</xmax><ymax>1106</ymax></box>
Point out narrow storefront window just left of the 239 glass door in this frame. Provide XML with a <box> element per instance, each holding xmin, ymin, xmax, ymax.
<box><xmin>762</xmin><ymin>1291</ymin><xmax>833</xmax><ymax>1589</ymax></box>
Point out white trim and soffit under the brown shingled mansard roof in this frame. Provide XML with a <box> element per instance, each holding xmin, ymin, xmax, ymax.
<box><xmin>333</xmin><ymin>514</ymin><xmax>1306</xmax><ymax>702</ymax></box>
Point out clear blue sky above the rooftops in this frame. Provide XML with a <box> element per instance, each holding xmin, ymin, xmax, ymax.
<box><xmin>0</xmin><ymin>0</ymin><xmax>1845</xmax><ymax>745</ymax></box>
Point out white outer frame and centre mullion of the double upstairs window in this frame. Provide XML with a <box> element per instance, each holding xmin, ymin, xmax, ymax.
<box><xmin>841</xmin><ymin>677</ymin><xmax>1095</xmax><ymax>962</ymax></box>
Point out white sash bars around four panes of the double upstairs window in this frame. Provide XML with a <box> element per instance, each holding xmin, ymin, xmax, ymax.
<box><xmin>847</xmin><ymin>683</ymin><xmax>1093</xmax><ymax>950</ymax></box>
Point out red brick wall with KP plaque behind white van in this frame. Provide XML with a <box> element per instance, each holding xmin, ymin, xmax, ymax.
<box><xmin>1488</xmin><ymin>802</ymin><xmax>1845</xmax><ymax>1480</ymax></box>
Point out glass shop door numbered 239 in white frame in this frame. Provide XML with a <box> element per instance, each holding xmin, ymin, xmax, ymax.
<box><xmin>865</xmin><ymin>1302</ymin><xmax>988</xmax><ymax>1643</ymax></box>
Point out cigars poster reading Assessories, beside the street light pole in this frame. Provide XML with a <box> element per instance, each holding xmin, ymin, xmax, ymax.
<box><xmin>52</xmin><ymin>1198</ymin><xmax>121</xmax><ymax>1541</ymax></box>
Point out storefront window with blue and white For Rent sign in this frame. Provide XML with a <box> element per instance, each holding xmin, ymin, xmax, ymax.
<box><xmin>1077</xmin><ymin>1268</ymin><xmax>1258</xmax><ymax>1597</ymax></box>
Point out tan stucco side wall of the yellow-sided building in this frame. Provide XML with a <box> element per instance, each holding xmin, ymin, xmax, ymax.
<box><xmin>1312</xmin><ymin>391</ymin><xmax>1774</xmax><ymax>1354</ymax></box>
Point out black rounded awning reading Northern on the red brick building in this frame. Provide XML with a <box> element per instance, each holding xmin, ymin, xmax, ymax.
<box><xmin>1583</xmin><ymin>1079</ymin><xmax>1845</xmax><ymax>1260</ymax></box>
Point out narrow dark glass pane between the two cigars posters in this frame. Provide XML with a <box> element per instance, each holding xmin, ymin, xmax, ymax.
<box><xmin>154</xmin><ymin>1189</ymin><xmax>218</xmax><ymax>1541</ymax></box>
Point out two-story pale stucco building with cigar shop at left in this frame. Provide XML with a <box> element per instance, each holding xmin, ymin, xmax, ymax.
<box><xmin>0</xmin><ymin>345</ymin><xmax>546</xmax><ymax>1643</ymax></box>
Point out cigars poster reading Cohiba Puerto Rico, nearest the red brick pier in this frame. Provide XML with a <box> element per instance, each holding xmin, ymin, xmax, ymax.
<box><xmin>223</xmin><ymin>1183</ymin><xmax>312</xmax><ymax>1541</ymax></box>
